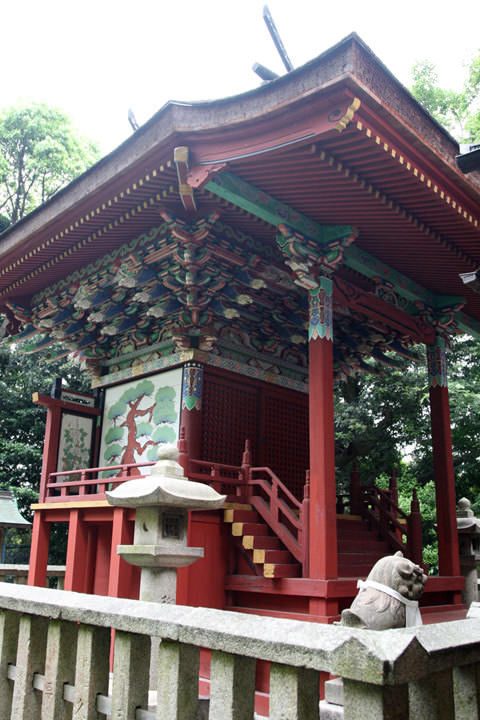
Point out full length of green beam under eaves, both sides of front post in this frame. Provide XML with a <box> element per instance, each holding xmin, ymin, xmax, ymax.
<box><xmin>205</xmin><ymin>172</ymin><xmax>466</xmax><ymax>318</ymax></box>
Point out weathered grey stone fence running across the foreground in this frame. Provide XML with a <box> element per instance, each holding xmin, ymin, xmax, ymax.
<box><xmin>0</xmin><ymin>583</ymin><xmax>480</xmax><ymax>720</ymax></box>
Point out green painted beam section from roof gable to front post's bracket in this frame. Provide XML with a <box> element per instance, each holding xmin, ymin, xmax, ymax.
<box><xmin>205</xmin><ymin>172</ymin><xmax>353</xmax><ymax>245</ymax></box>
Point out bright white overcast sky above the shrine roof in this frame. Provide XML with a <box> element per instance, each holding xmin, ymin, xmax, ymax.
<box><xmin>0</xmin><ymin>0</ymin><xmax>480</xmax><ymax>153</ymax></box>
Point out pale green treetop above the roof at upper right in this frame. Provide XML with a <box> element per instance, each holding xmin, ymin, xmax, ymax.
<box><xmin>411</xmin><ymin>54</ymin><xmax>480</xmax><ymax>142</ymax></box>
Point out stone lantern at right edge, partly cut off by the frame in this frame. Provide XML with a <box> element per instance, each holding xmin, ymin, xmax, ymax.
<box><xmin>457</xmin><ymin>498</ymin><xmax>480</xmax><ymax>607</ymax></box>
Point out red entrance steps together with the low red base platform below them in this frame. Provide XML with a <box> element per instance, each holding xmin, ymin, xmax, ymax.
<box><xmin>223</xmin><ymin>506</ymin><xmax>466</xmax><ymax>624</ymax></box>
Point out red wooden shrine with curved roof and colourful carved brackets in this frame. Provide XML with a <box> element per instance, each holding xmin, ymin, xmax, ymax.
<box><xmin>0</xmin><ymin>35</ymin><xmax>480</xmax><ymax>622</ymax></box>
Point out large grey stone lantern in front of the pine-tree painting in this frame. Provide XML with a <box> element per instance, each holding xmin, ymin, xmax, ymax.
<box><xmin>106</xmin><ymin>445</ymin><xmax>226</xmax><ymax>603</ymax></box>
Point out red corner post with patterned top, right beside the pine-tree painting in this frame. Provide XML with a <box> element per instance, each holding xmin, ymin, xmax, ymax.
<box><xmin>180</xmin><ymin>363</ymin><xmax>203</xmax><ymax>474</ymax></box>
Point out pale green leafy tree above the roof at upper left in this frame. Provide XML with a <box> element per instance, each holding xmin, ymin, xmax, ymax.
<box><xmin>0</xmin><ymin>103</ymin><xmax>99</xmax><ymax>226</ymax></box>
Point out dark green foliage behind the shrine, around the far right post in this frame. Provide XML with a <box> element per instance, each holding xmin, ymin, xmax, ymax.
<box><xmin>335</xmin><ymin>337</ymin><xmax>480</xmax><ymax>570</ymax></box>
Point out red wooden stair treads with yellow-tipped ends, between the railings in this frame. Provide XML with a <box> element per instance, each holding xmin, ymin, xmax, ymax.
<box><xmin>224</xmin><ymin>504</ymin><xmax>391</xmax><ymax>578</ymax></box>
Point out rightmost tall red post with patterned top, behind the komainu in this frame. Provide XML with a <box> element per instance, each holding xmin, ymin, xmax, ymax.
<box><xmin>427</xmin><ymin>336</ymin><xmax>460</xmax><ymax>575</ymax></box>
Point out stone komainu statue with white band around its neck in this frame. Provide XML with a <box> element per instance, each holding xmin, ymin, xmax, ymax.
<box><xmin>340</xmin><ymin>551</ymin><xmax>427</xmax><ymax>630</ymax></box>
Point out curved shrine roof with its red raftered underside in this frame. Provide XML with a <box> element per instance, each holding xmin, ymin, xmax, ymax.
<box><xmin>0</xmin><ymin>32</ymin><xmax>480</xmax><ymax>344</ymax></box>
